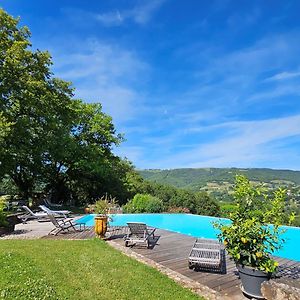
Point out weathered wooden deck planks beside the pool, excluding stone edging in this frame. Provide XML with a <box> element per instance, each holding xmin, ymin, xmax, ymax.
<box><xmin>45</xmin><ymin>228</ymin><xmax>300</xmax><ymax>299</ymax></box>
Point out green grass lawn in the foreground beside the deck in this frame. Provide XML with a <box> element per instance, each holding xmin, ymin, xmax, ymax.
<box><xmin>0</xmin><ymin>239</ymin><xmax>202</xmax><ymax>300</ymax></box>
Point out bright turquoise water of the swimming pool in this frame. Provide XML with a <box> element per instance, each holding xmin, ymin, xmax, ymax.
<box><xmin>78</xmin><ymin>214</ymin><xmax>300</xmax><ymax>261</ymax></box>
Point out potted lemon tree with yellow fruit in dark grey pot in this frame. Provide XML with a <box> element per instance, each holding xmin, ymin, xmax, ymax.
<box><xmin>214</xmin><ymin>175</ymin><xmax>292</xmax><ymax>299</ymax></box>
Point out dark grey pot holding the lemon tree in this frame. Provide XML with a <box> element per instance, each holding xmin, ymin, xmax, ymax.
<box><xmin>237</xmin><ymin>265</ymin><xmax>271</xmax><ymax>299</ymax></box>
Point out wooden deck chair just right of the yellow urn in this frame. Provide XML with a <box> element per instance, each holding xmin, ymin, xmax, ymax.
<box><xmin>124</xmin><ymin>222</ymin><xmax>156</xmax><ymax>248</ymax></box>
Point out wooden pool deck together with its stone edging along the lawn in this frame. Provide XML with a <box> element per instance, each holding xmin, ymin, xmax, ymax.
<box><xmin>43</xmin><ymin>227</ymin><xmax>300</xmax><ymax>300</ymax></box>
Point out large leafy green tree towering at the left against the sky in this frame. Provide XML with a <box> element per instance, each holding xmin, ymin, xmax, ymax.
<box><xmin>0</xmin><ymin>10</ymin><xmax>134</xmax><ymax>201</ymax></box>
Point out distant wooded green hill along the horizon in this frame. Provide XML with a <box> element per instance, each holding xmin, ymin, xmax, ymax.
<box><xmin>139</xmin><ymin>168</ymin><xmax>300</xmax><ymax>193</ymax></box>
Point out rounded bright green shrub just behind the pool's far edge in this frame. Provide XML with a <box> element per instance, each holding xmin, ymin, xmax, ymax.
<box><xmin>123</xmin><ymin>194</ymin><xmax>163</xmax><ymax>213</ymax></box>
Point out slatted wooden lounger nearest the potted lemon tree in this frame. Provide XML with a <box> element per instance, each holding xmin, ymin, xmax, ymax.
<box><xmin>188</xmin><ymin>239</ymin><xmax>224</xmax><ymax>272</ymax></box>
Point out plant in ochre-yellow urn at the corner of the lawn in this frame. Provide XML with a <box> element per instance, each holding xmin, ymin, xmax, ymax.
<box><xmin>94</xmin><ymin>195</ymin><xmax>115</xmax><ymax>238</ymax></box>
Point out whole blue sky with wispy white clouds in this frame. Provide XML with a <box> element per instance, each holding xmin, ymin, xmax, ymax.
<box><xmin>0</xmin><ymin>0</ymin><xmax>300</xmax><ymax>170</ymax></box>
